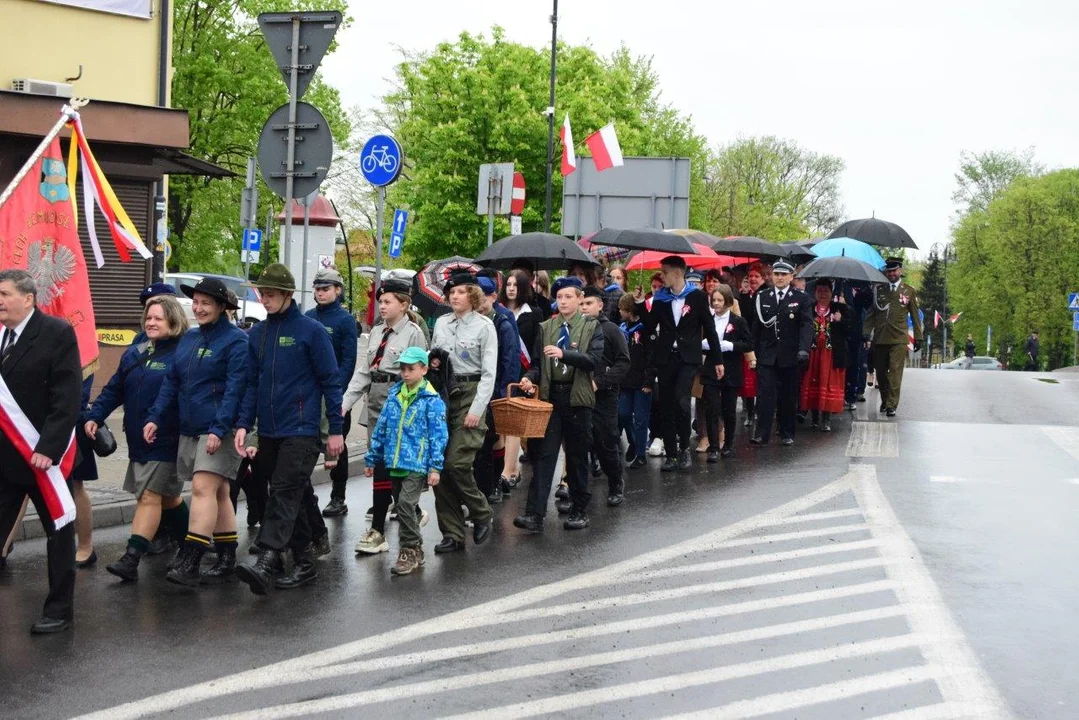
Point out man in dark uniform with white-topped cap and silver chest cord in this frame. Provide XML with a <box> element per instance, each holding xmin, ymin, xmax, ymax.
<box><xmin>748</xmin><ymin>260</ymin><xmax>812</xmax><ymax>446</ymax></box>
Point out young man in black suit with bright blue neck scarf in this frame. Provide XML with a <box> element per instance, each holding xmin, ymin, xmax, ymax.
<box><xmin>636</xmin><ymin>255</ymin><xmax>723</xmax><ymax>473</ymax></box>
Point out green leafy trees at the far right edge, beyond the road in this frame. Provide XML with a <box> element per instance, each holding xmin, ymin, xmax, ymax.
<box><xmin>948</xmin><ymin>169</ymin><xmax>1079</xmax><ymax>369</ymax></box>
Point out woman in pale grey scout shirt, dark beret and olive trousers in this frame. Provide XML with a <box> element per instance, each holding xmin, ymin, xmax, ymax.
<box><xmin>431</xmin><ymin>269</ymin><xmax>496</xmax><ymax>554</ymax></box>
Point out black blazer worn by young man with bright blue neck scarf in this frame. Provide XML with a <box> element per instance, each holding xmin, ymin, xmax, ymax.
<box><xmin>637</xmin><ymin>290</ymin><xmax>723</xmax><ymax>367</ymax></box>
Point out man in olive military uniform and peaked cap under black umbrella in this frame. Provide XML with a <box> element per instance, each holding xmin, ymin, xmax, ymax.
<box><xmin>863</xmin><ymin>258</ymin><xmax>921</xmax><ymax>418</ymax></box>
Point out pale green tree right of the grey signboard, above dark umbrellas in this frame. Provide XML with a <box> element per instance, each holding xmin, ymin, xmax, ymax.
<box><xmin>701</xmin><ymin>136</ymin><xmax>845</xmax><ymax>241</ymax></box>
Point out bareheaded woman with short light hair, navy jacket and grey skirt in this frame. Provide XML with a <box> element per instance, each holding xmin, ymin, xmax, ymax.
<box><xmin>85</xmin><ymin>296</ymin><xmax>188</xmax><ymax>581</ymax></box>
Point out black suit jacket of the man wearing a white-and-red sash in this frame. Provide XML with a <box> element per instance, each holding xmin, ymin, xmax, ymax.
<box><xmin>0</xmin><ymin>310</ymin><xmax>82</xmax><ymax>486</ymax></box>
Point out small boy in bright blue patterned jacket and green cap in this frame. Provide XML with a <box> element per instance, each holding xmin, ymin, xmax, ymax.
<box><xmin>364</xmin><ymin>347</ymin><xmax>450</xmax><ymax>575</ymax></box>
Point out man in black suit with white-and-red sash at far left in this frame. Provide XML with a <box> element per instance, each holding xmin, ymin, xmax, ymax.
<box><xmin>0</xmin><ymin>270</ymin><xmax>82</xmax><ymax>634</ymax></box>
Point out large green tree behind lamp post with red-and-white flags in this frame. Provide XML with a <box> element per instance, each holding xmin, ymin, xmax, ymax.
<box><xmin>378</xmin><ymin>27</ymin><xmax>707</xmax><ymax>264</ymax></box>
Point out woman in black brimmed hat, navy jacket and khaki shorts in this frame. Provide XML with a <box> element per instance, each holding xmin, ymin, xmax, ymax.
<box><xmin>142</xmin><ymin>277</ymin><xmax>247</xmax><ymax>586</ymax></box>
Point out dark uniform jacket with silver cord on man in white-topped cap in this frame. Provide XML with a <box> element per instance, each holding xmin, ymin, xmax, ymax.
<box><xmin>755</xmin><ymin>285</ymin><xmax>812</xmax><ymax>367</ymax></box>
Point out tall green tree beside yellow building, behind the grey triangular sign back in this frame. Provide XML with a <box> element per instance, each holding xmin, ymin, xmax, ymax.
<box><xmin>168</xmin><ymin>0</ymin><xmax>349</xmax><ymax>272</ymax></box>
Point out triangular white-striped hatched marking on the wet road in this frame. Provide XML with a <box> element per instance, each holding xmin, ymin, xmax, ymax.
<box><xmin>87</xmin><ymin>464</ymin><xmax>1009</xmax><ymax>720</ymax></box>
